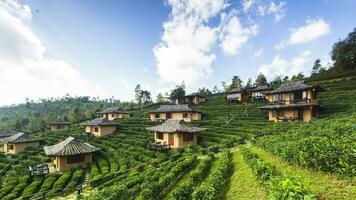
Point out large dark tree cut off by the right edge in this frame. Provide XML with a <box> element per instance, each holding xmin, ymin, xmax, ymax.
<box><xmin>331</xmin><ymin>28</ymin><xmax>356</xmax><ymax>71</ymax></box>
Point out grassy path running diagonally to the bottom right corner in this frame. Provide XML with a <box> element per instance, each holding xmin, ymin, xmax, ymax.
<box><xmin>251</xmin><ymin>147</ymin><xmax>356</xmax><ymax>200</ymax></box>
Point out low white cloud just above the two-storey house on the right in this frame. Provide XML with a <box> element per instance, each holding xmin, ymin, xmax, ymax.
<box><xmin>258</xmin><ymin>50</ymin><xmax>311</xmax><ymax>79</ymax></box>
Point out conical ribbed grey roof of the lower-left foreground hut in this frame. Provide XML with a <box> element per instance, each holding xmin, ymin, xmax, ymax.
<box><xmin>43</xmin><ymin>137</ymin><xmax>100</xmax><ymax>156</ymax></box>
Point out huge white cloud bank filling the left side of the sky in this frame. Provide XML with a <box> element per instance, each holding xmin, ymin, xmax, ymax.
<box><xmin>0</xmin><ymin>0</ymin><xmax>105</xmax><ymax>105</ymax></box>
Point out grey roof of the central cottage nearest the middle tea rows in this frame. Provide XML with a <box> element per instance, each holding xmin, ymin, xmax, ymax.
<box><xmin>146</xmin><ymin>119</ymin><xmax>206</xmax><ymax>133</ymax></box>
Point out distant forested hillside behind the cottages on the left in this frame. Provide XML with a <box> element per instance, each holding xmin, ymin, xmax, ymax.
<box><xmin>0</xmin><ymin>95</ymin><xmax>137</xmax><ymax>132</ymax></box>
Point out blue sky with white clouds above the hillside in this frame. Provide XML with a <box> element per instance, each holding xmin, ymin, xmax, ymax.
<box><xmin>0</xmin><ymin>0</ymin><xmax>356</xmax><ymax>106</ymax></box>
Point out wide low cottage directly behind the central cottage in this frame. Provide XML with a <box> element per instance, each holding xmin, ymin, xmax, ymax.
<box><xmin>150</xmin><ymin>104</ymin><xmax>202</xmax><ymax>122</ymax></box>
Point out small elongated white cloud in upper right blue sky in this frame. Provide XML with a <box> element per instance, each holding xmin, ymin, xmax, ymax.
<box><xmin>275</xmin><ymin>19</ymin><xmax>331</xmax><ymax>49</ymax></box>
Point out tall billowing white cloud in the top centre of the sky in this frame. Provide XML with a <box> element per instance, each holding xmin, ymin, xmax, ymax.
<box><xmin>153</xmin><ymin>0</ymin><xmax>258</xmax><ymax>90</ymax></box>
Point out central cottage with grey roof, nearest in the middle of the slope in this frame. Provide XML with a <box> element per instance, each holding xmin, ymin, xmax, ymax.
<box><xmin>146</xmin><ymin>119</ymin><xmax>205</xmax><ymax>148</ymax></box>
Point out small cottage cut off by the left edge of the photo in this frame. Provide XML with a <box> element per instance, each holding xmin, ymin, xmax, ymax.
<box><xmin>0</xmin><ymin>133</ymin><xmax>41</xmax><ymax>154</ymax></box>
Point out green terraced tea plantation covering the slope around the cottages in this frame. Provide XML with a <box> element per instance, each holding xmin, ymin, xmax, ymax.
<box><xmin>0</xmin><ymin>79</ymin><xmax>356</xmax><ymax>200</ymax></box>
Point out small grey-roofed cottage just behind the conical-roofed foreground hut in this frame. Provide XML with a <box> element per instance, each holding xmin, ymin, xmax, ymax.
<box><xmin>80</xmin><ymin>118</ymin><xmax>119</xmax><ymax>137</ymax></box>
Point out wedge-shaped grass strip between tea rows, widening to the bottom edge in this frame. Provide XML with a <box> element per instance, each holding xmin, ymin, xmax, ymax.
<box><xmin>226</xmin><ymin>150</ymin><xmax>266</xmax><ymax>200</ymax></box>
